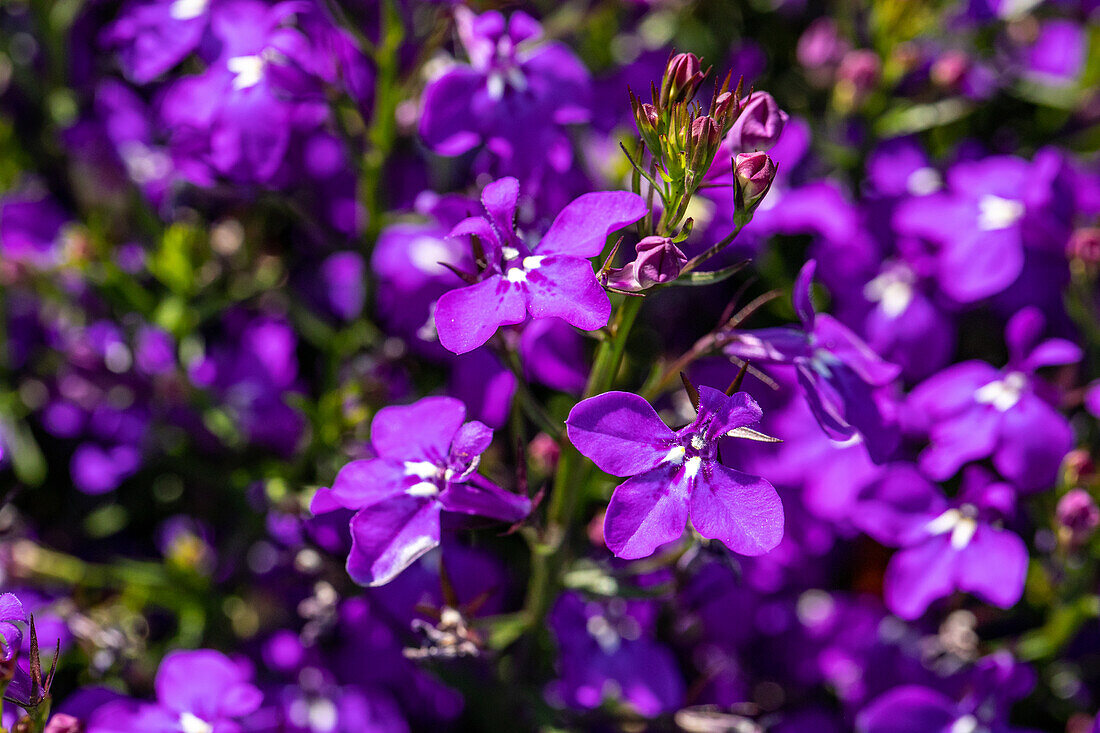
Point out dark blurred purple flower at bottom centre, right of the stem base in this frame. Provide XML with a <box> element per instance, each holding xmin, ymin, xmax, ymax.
<box><xmin>547</xmin><ymin>592</ymin><xmax>684</xmax><ymax>716</ymax></box>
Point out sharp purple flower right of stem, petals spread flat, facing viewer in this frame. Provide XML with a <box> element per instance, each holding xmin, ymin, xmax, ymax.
<box><xmin>565</xmin><ymin>386</ymin><xmax>783</xmax><ymax>559</ymax></box>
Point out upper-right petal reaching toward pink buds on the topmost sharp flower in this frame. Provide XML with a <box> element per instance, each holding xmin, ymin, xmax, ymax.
<box><xmin>535</xmin><ymin>190</ymin><xmax>647</xmax><ymax>258</ymax></box>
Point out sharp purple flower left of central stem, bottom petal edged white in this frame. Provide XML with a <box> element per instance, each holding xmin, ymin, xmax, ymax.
<box><xmin>312</xmin><ymin>397</ymin><xmax>531</xmax><ymax>586</ymax></box>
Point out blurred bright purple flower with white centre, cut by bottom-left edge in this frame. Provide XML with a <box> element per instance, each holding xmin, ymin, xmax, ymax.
<box><xmin>88</xmin><ymin>649</ymin><xmax>263</xmax><ymax>733</ymax></box>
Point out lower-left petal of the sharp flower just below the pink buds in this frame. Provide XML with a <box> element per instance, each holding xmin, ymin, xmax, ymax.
<box><xmin>436</xmin><ymin>275</ymin><xmax>528</xmax><ymax>353</ymax></box>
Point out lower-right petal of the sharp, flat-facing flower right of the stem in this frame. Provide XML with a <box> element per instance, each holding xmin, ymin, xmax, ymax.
<box><xmin>691</xmin><ymin>461</ymin><xmax>783</xmax><ymax>556</ymax></box>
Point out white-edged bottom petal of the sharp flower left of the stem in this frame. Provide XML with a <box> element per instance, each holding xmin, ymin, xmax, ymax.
<box><xmin>348</xmin><ymin>496</ymin><xmax>441</xmax><ymax>586</ymax></box>
